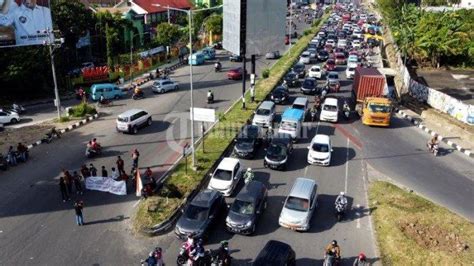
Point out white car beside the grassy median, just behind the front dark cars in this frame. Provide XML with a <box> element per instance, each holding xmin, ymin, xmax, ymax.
<box><xmin>207</xmin><ymin>157</ymin><xmax>243</xmax><ymax>197</ymax></box>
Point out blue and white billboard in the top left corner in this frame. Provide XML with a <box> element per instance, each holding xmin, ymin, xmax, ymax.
<box><xmin>0</xmin><ymin>0</ymin><xmax>53</xmax><ymax>47</ymax></box>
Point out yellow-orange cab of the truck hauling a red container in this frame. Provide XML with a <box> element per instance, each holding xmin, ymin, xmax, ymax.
<box><xmin>361</xmin><ymin>97</ymin><xmax>392</xmax><ymax>127</ymax></box>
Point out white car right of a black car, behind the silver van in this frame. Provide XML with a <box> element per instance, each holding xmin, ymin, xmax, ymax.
<box><xmin>308</xmin><ymin>134</ymin><xmax>332</xmax><ymax>166</ymax></box>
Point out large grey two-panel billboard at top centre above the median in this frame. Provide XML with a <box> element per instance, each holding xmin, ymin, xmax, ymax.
<box><xmin>222</xmin><ymin>0</ymin><xmax>287</xmax><ymax>55</ymax></box>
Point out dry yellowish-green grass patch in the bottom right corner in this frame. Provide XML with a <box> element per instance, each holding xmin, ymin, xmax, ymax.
<box><xmin>369</xmin><ymin>181</ymin><xmax>474</xmax><ymax>265</ymax></box>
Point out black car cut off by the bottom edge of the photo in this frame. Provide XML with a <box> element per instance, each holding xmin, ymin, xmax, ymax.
<box><xmin>252</xmin><ymin>240</ymin><xmax>296</xmax><ymax>266</ymax></box>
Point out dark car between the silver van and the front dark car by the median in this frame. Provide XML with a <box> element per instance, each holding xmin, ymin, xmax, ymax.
<box><xmin>225</xmin><ymin>180</ymin><xmax>267</xmax><ymax>235</ymax></box>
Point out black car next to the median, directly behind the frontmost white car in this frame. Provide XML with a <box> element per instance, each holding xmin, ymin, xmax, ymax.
<box><xmin>234</xmin><ymin>125</ymin><xmax>262</xmax><ymax>158</ymax></box>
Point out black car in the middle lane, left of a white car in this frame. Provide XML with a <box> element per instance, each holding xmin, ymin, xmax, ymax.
<box><xmin>263</xmin><ymin>133</ymin><xmax>293</xmax><ymax>170</ymax></box>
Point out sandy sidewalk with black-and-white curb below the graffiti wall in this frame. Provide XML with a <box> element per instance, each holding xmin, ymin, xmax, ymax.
<box><xmin>398</xmin><ymin>106</ymin><xmax>474</xmax><ymax>158</ymax></box>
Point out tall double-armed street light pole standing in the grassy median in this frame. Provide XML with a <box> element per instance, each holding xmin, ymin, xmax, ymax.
<box><xmin>153</xmin><ymin>4</ymin><xmax>222</xmax><ymax>168</ymax></box>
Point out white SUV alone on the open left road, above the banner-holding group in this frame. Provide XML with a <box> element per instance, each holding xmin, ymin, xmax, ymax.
<box><xmin>116</xmin><ymin>109</ymin><xmax>152</xmax><ymax>134</ymax></box>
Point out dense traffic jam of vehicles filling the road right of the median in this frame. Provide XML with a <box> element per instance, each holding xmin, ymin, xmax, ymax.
<box><xmin>174</xmin><ymin>4</ymin><xmax>386</xmax><ymax>265</ymax></box>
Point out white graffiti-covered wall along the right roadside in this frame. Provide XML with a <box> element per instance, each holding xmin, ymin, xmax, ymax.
<box><xmin>408</xmin><ymin>79</ymin><xmax>474</xmax><ymax>125</ymax></box>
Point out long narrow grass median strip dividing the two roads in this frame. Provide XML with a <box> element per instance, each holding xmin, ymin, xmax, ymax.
<box><xmin>132</xmin><ymin>14</ymin><xmax>328</xmax><ymax>234</ymax></box>
